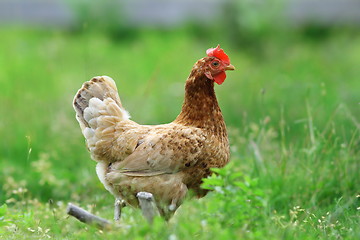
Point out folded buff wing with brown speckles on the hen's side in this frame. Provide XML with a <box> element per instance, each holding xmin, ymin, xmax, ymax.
<box><xmin>110</xmin><ymin>123</ymin><xmax>206</xmax><ymax>176</ymax></box>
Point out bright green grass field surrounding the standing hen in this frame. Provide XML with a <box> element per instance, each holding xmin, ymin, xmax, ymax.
<box><xmin>0</xmin><ymin>29</ymin><xmax>360</xmax><ymax>239</ymax></box>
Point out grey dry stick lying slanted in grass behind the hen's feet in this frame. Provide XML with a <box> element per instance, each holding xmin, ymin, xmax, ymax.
<box><xmin>66</xmin><ymin>203</ymin><xmax>114</xmax><ymax>229</ymax></box>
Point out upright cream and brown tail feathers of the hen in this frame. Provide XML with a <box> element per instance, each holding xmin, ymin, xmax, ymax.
<box><xmin>74</xmin><ymin>76</ymin><xmax>130</xmax><ymax>160</ymax></box>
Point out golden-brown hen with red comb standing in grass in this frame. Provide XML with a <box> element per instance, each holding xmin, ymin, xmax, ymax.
<box><xmin>73</xmin><ymin>46</ymin><xmax>235</xmax><ymax>221</ymax></box>
